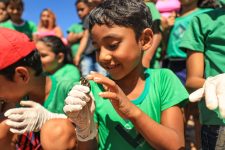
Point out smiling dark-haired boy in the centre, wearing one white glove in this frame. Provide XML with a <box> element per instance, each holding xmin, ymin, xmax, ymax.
<box><xmin>61</xmin><ymin>0</ymin><xmax>188</xmax><ymax>150</ymax></box>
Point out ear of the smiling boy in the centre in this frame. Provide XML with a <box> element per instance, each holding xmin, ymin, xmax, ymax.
<box><xmin>140</xmin><ymin>28</ymin><xmax>153</xmax><ymax>50</ymax></box>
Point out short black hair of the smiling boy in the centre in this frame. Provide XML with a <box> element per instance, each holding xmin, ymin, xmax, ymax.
<box><xmin>89</xmin><ymin>0</ymin><xmax>152</xmax><ymax>39</ymax></box>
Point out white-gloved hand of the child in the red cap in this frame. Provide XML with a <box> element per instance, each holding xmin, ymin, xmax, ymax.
<box><xmin>4</xmin><ymin>101</ymin><xmax>67</xmax><ymax>134</ymax></box>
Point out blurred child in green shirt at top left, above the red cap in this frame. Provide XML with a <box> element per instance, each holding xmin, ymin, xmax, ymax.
<box><xmin>0</xmin><ymin>0</ymin><xmax>37</xmax><ymax>39</ymax></box>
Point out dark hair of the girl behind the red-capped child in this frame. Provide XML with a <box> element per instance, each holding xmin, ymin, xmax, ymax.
<box><xmin>38</xmin><ymin>35</ymin><xmax>73</xmax><ymax>64</ymax></box>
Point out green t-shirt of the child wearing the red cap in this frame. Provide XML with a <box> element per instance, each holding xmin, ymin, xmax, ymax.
<box><xmin>44</xmin><ymin>76</ymin><xmax>75</xmax><ymax>113</ymax></box>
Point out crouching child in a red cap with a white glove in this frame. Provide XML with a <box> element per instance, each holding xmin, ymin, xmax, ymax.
<box><xmin>0</xmin><ymin>28</ymin><xmax>76</xmax><ymax>150</ymax></box>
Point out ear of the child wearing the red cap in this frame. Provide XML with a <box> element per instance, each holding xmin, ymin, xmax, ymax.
<box><xmin>14</xmin><ymin>66</ymin><xmax>30</xmax><ymax>83</ymax></box>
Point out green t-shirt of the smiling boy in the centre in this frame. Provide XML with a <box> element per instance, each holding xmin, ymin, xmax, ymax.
<box><xmin>91</xmin><ymin>69</ymin><xmax>188</xmax><ymax>150</ymax></box>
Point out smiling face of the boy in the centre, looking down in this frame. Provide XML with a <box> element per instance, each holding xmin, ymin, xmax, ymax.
<box><xmin>91</xmin><ymin>24</ymin><xmax>142</xmax><ymax>80</ymax></box>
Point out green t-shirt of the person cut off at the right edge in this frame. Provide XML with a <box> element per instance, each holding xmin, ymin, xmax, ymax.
<box><xmin>180</xmin><ymin>9</ymin><xmax>225</xmax><ymax>125</ymax></box>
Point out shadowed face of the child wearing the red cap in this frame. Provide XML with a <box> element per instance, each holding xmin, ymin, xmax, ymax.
<box><xmin>0</xmin><ymin>75</ymin><xmax>26</xmax><ymax>102</ymax></box>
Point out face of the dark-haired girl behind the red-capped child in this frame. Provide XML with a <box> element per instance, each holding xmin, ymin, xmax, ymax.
<box><xmin>36</xmin><ymin>41</ymin><xmax>59</xmax><ymax>73</ymax></box>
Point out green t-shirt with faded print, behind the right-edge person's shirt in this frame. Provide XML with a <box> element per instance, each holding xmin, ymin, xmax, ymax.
<box><xmin>166</xmin><ymin>9</ymin><xmax>211</xmax><ymax>59</ymax></box>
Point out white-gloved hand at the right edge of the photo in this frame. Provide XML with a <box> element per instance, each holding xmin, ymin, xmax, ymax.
<box><xmin>189</xmin><ymin>73</ymin><xmax>225</xmax><ymax>118</ymax></box>
